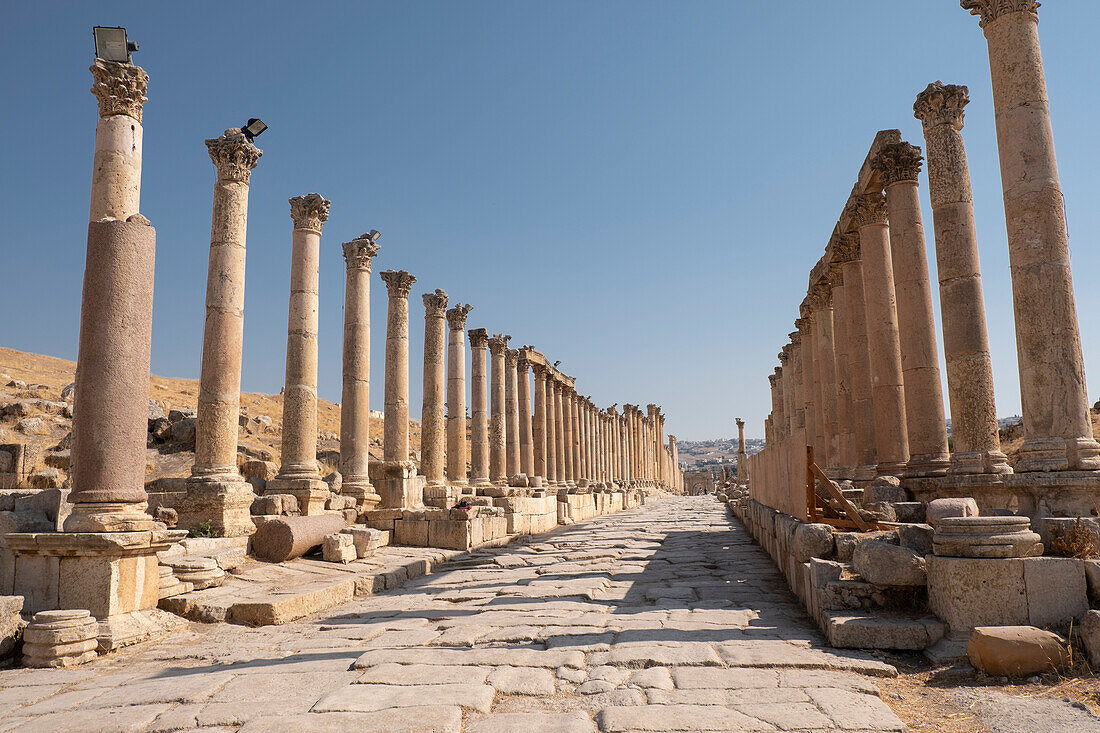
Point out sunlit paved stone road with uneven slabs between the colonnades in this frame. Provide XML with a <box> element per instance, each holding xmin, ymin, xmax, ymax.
<box><xmin>0</xmin><ymin>497</ymin><xmax>904</xmax><ymax>733</ymax></box>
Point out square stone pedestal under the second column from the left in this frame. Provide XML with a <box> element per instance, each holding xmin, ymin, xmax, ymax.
<box><xmin>172</xmin><ymin>475</ymin><xmax>256</xmax><ymax>537</ymax></box>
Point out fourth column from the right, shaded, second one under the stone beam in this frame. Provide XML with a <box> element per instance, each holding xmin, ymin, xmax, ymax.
<box><xmin>855</xmin><ymin>194</ymin><xmax>909</xmax><ymax>475</ymax></box>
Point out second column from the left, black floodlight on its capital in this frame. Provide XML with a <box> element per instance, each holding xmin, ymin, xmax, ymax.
<box><xmin>187</xmin><ymin>128</ymin><xmax>263</xmax><ymax>537</ymax></box>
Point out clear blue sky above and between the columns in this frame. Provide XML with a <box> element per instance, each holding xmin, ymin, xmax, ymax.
<box><xmin>0</xmin><ymin>0</ymin><xmax>1100</xmax><ymax>439</ymax></box>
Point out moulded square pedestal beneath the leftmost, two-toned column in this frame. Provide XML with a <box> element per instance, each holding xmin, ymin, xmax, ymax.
<box><xmin>6</xmin><ymin>532</ymin><xmax>169</xmax><ymax>652</ymax></box>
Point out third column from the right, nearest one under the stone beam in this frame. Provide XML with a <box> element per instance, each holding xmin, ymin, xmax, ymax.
<box><xmin>871</xmin><ymin>142</ymin><xmax>949</xmax><ymax>477</ymax></box>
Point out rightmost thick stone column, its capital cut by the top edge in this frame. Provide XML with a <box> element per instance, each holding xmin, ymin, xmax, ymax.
<box><xmin>961</xmin><ymin>0</ymin><xmax>1100</xmax><ymax>473</ymax></box>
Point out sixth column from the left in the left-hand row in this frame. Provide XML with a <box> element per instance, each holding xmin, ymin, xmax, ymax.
<box><xmin>418</xmin><ymin>288</ymin><xmax>448</xmax><ymax>486</ymax></box>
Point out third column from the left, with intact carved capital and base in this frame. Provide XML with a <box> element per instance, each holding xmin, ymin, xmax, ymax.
<box><xmin>264</xmin><ymin>194</ymin><xmax>330</xmax><ymax>515</ymax></box>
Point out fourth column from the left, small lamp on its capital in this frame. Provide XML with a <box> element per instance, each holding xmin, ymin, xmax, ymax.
<box><xmin>340</xmin><ymin>231</ymin><xmax>382</xmax><ymax>510</ymax></box>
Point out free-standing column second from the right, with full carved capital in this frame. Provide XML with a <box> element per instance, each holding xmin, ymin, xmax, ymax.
<box><xmin>913</xmin><ymin>81</ymin><xmax>1012</xmax><ymax>473</ymax></box>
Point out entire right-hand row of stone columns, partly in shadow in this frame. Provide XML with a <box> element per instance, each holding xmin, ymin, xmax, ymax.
<box><xmin>766</xmin><ymin>0</ymin><xmax>1100</xmax><ymax>497</ymax></box>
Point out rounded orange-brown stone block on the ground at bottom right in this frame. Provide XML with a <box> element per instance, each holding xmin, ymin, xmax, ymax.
<box><xmin>966</xmin><ymin>626</ymin><xmax>1069</xmax><ymax>677</ymax></box>
